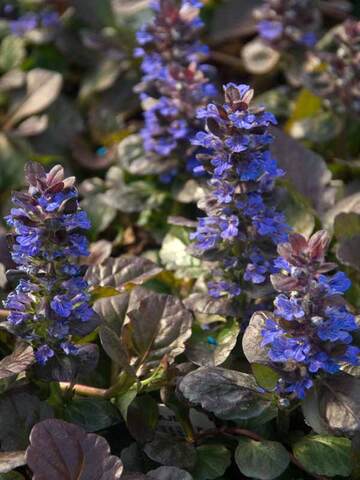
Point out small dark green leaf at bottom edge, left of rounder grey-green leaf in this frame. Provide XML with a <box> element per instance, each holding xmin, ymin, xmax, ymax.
<box><xmin>193</xmin><ymin>444</ymin><xmax>231</xmax><ymax>480</ymax></box>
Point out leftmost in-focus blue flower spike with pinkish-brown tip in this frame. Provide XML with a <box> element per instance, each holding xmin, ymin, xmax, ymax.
<box><xmin>4</xmin><ymin>163</ymin><xmax>98</xmax><ymax>364</ymax></box>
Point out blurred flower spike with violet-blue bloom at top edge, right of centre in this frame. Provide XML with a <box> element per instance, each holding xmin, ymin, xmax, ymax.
<box><xmin>255</xmin><ymin>0</ymin><xmax>321</xmax><ymax>51</ymax></box>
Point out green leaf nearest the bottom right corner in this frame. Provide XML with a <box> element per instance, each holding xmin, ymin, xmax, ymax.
<box><xmin>293</xmin><ymin>435</ymin><xmax>351</xmax><ymax>477</ymax></box>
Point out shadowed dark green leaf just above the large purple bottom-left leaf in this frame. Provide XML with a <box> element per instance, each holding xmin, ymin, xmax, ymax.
<box><xmin>64</xmin><ymin>398</ymin><xmax>120</xmax><ymax>432</ymax></box>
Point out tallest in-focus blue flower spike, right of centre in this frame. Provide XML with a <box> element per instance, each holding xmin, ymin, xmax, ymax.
<box><xmin>191</xmin><ymin>83</ymin><xmax>288</xmax><ymax>297</ymax></box>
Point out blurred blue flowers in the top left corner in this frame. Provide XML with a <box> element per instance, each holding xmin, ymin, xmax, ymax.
<box><xmin>1</xmin><ymin>4</ymin><xmax>60</xmax><ymax>37</ymax></box>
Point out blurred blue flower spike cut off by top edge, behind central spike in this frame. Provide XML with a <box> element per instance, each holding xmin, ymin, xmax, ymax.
<box><xmin>135</xmin><ymin>0</ymin><xmax>216</xmax><ymax>182</ymax></box>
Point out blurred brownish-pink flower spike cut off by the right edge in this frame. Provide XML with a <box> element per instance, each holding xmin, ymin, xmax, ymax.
<box><xmin>308</xmin><ymin>19</ymin><xmax>360</xmax><ymax>114</ymax></box>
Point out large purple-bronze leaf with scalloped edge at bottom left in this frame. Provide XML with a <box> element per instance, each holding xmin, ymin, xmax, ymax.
<box><xmin>26</xmin><ymin>419</ymin><xmax>123</xmax><ymax>480</ymax></box>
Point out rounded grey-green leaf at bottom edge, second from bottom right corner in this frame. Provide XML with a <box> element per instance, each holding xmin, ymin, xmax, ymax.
<box><xmin>235</xmin><ymin>438</ymin><xmax>290</xmax><ymax>480</ymax></box>
